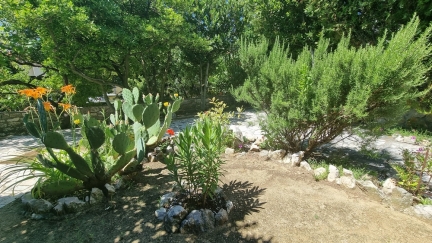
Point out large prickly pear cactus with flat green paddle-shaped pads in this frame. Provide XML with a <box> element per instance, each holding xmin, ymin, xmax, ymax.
<box><xmin>9</xmin><ymin>86</ymin><xmax>181</xmax><ymax>196</ymax></box>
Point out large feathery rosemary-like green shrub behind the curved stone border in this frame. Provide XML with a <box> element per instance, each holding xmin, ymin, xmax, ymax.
<box><xmin>233</xmin><ymin>18</ymin><xmax>431</xmax><ymax>154</ymax></box>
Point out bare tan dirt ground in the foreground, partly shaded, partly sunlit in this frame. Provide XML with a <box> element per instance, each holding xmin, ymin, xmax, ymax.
<box><xmin>0</xmin><ymin>153</ymin><xmax>432</xmax><ymax>243</ymax></box>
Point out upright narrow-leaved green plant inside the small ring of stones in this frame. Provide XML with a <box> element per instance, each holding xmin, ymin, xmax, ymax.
<box><xmin>166</xmin><ymin>117</ymin><xmax>224</xmax><ymax>205</ymax></box>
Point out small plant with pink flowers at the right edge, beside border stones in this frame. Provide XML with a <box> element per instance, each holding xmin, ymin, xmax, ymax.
<box><xmin>393</xmin><ymin>148</ymin><xmax>432</xmax><ymax>195</ymax></box>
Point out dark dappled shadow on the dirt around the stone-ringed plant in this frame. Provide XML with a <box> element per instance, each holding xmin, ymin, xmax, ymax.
<box><xmin>0</xmin><ymin>163</ymin><xmax>271</xmax><ymax>243</ymax></box>
